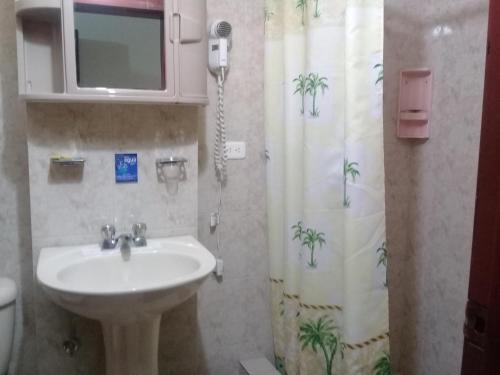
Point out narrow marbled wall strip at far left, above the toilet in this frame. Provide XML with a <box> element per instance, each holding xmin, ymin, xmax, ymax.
<box><xmin>0</xmin><ymin>1</ymin><xmax>35</xmax><ymax>375</ymax></box>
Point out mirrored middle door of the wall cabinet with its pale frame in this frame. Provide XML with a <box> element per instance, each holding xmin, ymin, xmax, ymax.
<box><xmin>63</xmin><ymin>0</ymin><xmax>175</xmax><ymax>97</ymax></box>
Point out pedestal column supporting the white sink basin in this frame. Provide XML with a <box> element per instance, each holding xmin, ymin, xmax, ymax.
<box><xmin>101</xmin><ymin>316</ymin><xmax>161</xmax><ymax>375</ymax></box>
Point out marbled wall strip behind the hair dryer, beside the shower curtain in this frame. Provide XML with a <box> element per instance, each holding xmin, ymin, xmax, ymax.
<box><xmin>198</xmin><ymin>0</ymin><xmax>273</xmax><ymax>375</ymax></box>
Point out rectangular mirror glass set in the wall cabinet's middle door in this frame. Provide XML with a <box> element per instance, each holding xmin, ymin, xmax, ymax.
<box><xmin>74</xmin><ymin>0</ymin><xmax>165</xmax><ymax>90</ymax></box>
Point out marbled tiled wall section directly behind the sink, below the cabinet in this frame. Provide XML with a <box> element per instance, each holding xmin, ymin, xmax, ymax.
<box><xmin>28</xmin><ymin>104</ymin><xmax>199</xmax><ymax>375</ymax></box>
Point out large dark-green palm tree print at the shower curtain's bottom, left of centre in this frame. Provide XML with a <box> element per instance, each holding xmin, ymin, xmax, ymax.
<box><xmin>299</xmin><ymin>317</ymin><xmax>343</xmax><ymax>375</ymax></box>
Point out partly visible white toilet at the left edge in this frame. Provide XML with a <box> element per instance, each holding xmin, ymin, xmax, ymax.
<box><xmin>0</xmin><ymin>278</ymin><xmax>17</xmax><ymax>375</ymax></box>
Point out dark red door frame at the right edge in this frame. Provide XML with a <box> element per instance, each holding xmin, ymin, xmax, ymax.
<box><xmin>462</xmin><ymin>0</ymin><xmax>500</xmax><ymax>375</ymax></box>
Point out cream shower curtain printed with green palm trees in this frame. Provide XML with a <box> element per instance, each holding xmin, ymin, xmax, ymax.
<box><xmin>265</xmin><ymin>0</ymin><xmax>390</xmax><ymax>375</ymax></box>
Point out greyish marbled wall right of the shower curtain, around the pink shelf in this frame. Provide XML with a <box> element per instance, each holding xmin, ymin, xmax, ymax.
<box><xmin>384</xmin><ymin>0</ymin><xmax>488</xmax><ymax>375</ymax></box>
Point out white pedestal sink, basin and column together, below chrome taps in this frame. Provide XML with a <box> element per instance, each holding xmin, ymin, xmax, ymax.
<box><xmin>37</xmin><ymin>236</ymin><xmax>215</xmax><ymax>375</ymax></box>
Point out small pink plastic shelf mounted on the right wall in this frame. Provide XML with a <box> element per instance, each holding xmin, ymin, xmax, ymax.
<box><xmin>397</xmin><ymin>69</ymin><xmax>432</xmax><ymax>139</ymax></box>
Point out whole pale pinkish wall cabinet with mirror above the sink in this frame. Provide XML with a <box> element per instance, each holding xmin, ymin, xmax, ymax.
<box><xmin>16</xmin><ymin>0</ymin><xmax>208</xmax><ymax>105</ymax></box>
